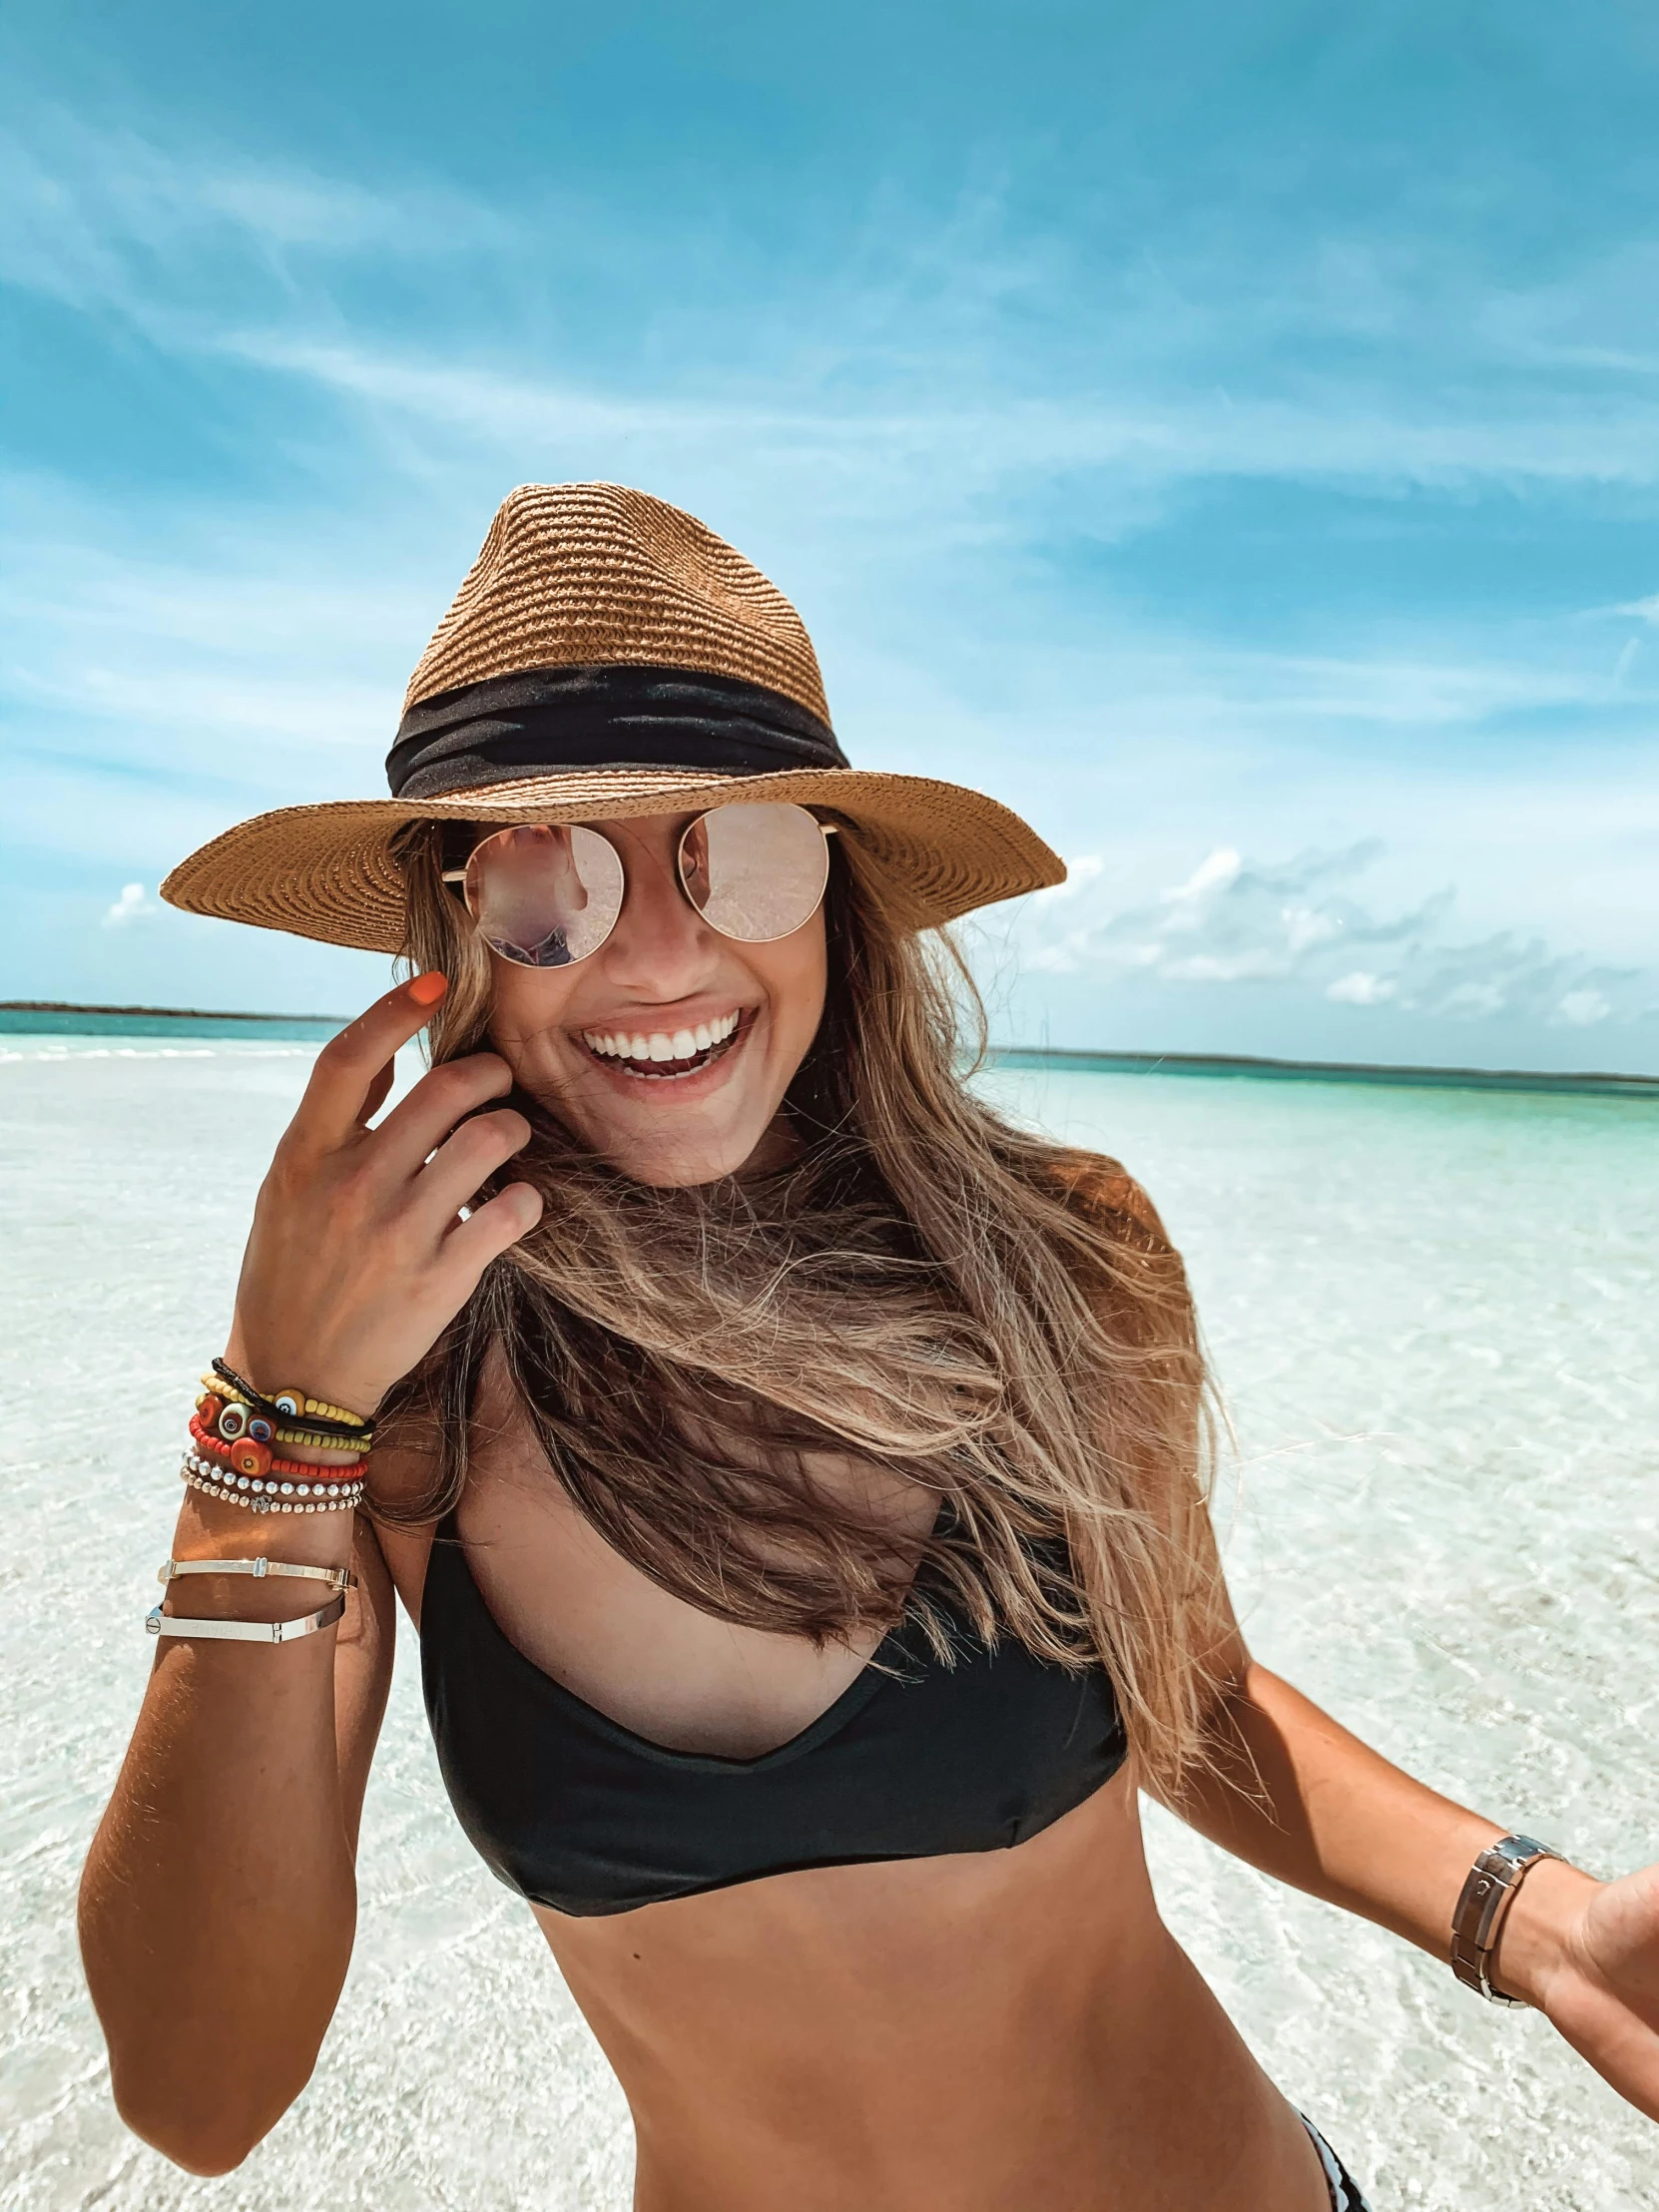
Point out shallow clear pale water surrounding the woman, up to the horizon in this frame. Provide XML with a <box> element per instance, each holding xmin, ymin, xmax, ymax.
<box><xmin>0</xmin><ymin>1037</ymin><xmax>1659</xmax><ymax>2212</ymax></box>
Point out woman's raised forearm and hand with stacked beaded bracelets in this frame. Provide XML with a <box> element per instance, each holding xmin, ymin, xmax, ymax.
<box><xmin>82</xmin><ymin>975</ymin><xmax>542</xmax><ymax>2170</ymax></box>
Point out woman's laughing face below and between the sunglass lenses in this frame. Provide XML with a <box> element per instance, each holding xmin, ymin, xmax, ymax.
<box><xmin>489</xmin><ymin>814</ymin><xmax>826</xmax><ymax>1186</ymax></box>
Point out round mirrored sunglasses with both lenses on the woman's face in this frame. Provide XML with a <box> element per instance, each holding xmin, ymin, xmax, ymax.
<box><xmin>444</xmin><ymin>801</ymin><xmax>836</xmax><ymax>966</ymax></box>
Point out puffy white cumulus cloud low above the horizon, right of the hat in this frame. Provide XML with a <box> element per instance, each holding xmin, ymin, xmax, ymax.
<box><xmin>1013</xmin><ymin>840</ymin><xmax>1659</xmax><ymax>1028</ymax></box>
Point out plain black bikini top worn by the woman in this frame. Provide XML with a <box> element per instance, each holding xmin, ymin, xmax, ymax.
<box><xmin>420</xmin><ymin>1522</ymin><xmax>1128</xmax><ymax>1916</ymax></box>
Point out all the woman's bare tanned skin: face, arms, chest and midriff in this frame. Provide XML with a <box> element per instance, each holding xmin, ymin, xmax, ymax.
<box><xmin>80</xmin><ymin>817</ymin><xmax>1659</xmax><ymax>2212</ymax></box>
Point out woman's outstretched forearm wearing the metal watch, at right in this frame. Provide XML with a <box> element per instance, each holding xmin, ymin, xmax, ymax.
<box><xmin>1177</xmin><ymin>1661</ymin><xmax>1595</xmax><ymax>1999</ymax></box>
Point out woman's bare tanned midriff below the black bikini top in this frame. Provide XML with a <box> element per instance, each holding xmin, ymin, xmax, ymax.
<box><xmin>535</xmin><ymin>1774</ymin><xmax>1330</xmax><ymax>2212</ymax></box>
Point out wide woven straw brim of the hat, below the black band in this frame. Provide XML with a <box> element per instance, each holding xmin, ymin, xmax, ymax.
<box><xmin>162</xmin><ymin>768</ymin><xmax>1066</xmax><ymax>953</ymax></box>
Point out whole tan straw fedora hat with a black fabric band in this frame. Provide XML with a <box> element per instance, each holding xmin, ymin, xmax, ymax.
<box><xmin>162</xmin><ymin>484</ymin><xmax>1066</xmax><ymax>953</ymax></box>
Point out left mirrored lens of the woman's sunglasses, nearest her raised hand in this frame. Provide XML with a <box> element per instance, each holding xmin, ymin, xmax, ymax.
<box><xmin>464</xmin><ymin>823</ymin><xmax>622</xmax><ymax>966</ymax></box>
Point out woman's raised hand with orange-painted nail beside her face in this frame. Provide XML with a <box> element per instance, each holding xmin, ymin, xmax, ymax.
<box><xmin>228</xmin><ymin>975</ymin><xmax>542</xmax><ymax>1413</ymax></box>
